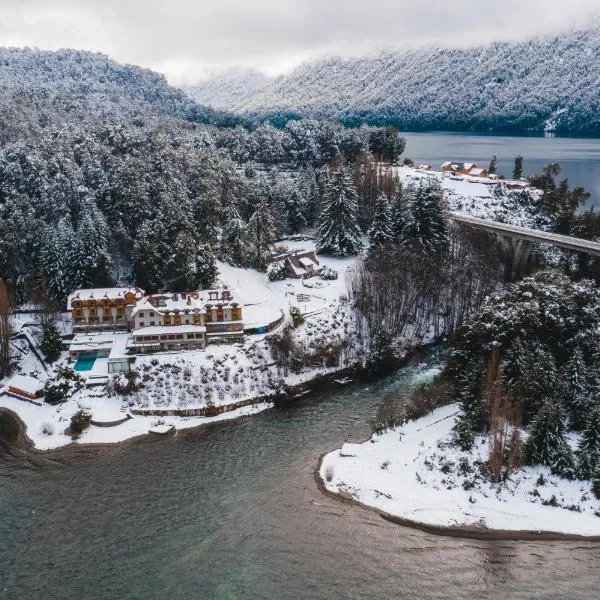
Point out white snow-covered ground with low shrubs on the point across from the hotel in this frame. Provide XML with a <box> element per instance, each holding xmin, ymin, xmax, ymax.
<box><xmin>320</xmin><ymin>404</ymin><xmax>600</xmax><ymax>535</ymax></box>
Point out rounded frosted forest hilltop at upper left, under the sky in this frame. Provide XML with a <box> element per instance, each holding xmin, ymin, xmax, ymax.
<box><xmin>0</xmin><ymin>48</ymin><xmax>239</xmax><ymax>143</ymax></box>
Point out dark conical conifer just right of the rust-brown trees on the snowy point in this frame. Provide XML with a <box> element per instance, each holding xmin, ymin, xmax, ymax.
<box><xmin>525</xmin><ymin>401</ymin><xmax>574</xmax><ymax>476</ymax></box>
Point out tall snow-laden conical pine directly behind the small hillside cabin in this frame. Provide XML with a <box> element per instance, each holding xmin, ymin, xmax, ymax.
<box><xmin>317</xmin><ymin>167</ymin><xmax>362</xmax><ymax>256</ymax></box>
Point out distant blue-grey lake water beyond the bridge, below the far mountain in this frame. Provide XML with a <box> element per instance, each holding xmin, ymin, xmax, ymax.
<box><xmin>402</xmin><ymin>132</ymin><xmax>600</xmax><ymax>209</ymax></box>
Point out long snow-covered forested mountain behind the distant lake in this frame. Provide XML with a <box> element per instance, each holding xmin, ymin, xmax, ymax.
<box><xmin>190</xmin><ymin>24</ymin><xmax>600</xmax><ymax>133</ymax></box>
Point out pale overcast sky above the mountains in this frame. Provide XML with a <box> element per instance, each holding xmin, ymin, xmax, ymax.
<box><xmin>0</xmin><ymin>0</ymin><xmax>600</xmax><ymax>84</ymax></box>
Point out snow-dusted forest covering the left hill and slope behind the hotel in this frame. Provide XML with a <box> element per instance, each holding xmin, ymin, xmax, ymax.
<box><xmin>0</xmin><ymin>49</ymin><xmax>404</xmax><ymax>306</ymax></box>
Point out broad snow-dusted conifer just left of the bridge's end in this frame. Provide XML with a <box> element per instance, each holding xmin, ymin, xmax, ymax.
<box><xmin>396</xmin><ymin>182</ymin><xmax>448</xmax><ymax>252</ymax></box>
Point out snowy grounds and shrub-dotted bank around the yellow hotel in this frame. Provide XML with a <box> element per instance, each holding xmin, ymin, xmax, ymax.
<box><xmin>0</xmin><ymin>240</ymin><xmax>357</xmax><ymax>449</ymax></box>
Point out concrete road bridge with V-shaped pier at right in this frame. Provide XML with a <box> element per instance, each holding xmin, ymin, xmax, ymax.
<box><xmin>446</xmin><ymin>211</ymin><xmax>600</xmax><ymax>279</ymax></box>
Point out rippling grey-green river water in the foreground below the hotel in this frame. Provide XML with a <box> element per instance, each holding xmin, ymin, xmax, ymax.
<box><xmin>0</xmin><ymin>356</ymin><xmax>600</xmax><ymax>600</ymax></box>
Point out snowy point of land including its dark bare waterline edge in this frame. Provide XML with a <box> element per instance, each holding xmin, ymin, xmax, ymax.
<box><xmin>314</xmin><ymin>403</ymin><xmax>600</xmax><ymax>542</ymax></box>
